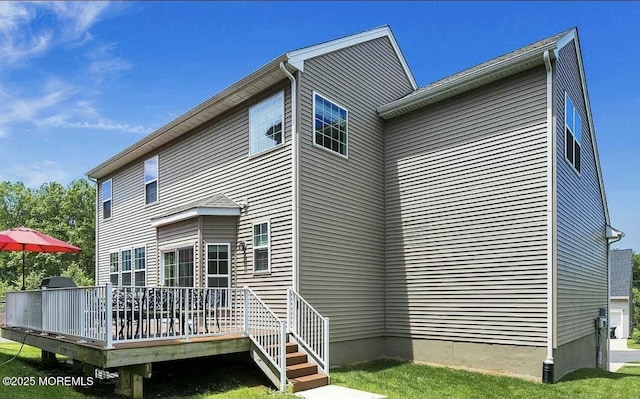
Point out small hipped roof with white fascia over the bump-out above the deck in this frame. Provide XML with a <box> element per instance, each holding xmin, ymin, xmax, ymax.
<box><xmin>151</xmin><ymin>193</ymin><xmax>241</xmax><ymax>227</ymax></box>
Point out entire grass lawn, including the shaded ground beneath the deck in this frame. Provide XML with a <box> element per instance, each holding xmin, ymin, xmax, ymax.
<box><xmin>0</xmin><ymin>343</ymin><xmax>640</xmax><ymax>399</ymax></box>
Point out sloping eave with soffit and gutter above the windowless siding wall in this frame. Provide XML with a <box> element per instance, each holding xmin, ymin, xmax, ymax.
<box><xmin>378</xmin><ymin>42</ymin><xmax>557</xmax><ymax>119</ymax></box>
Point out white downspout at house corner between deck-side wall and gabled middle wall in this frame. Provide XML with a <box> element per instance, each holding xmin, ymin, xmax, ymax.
<box><xmin>280</xmin><ymin>62</ymin><xmax>300</xmax><ymax>292</ymax></box>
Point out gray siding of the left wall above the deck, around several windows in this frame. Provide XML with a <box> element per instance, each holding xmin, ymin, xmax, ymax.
<box><xmin>98</xmin><ymin>83</ymin><xmax>291</xmax><ymax>315</ymax></box>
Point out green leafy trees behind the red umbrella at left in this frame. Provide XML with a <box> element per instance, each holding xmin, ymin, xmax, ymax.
<box><xmin>0</xmin><ymin>179</ymin><xmax>95</xmax><ymax>291</ymax></box>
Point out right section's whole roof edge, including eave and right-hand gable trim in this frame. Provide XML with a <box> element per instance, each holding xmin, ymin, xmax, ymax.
<box><xmin>378</xmin><ymin>28</ymin><xmax>611</xmax><ymax>226</ymax></box>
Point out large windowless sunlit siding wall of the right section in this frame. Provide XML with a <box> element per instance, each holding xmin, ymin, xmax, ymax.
<box><xmin>385</xmin><ymin>67</ymin><xmax>547</xmax><ymax>346</ymax></box>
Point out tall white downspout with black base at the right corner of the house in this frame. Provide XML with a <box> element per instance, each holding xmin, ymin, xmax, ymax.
<box><xmin>542</xmin><ymin>50</ymin><xmax>554</xmax><ymax>384</ymax></box>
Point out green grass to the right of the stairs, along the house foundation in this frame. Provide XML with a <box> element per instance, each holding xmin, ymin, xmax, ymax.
<box><xmin>331</xmin><ymin>360</ymin><xmax>640</xmax><ymax>399</ymax></box>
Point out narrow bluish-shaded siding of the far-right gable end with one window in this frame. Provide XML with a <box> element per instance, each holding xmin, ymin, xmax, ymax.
<box><xmin>555</xmin><ymin>42</ymin><xmax>607</xmax><ymax>345</ymax></box>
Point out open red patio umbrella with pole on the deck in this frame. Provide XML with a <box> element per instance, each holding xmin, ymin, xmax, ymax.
<box><xmin>0</xmin><ymin>227</ymin><xmax>80</xmax><ymax>290</ymax></box>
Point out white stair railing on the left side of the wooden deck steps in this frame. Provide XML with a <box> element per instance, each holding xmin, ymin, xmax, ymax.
<box><xmin>244</xmin><ymin>286</ymin><xmax>287</xmax><ymax>392</ymax></box>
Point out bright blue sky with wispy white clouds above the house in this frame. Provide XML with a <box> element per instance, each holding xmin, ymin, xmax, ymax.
<box><xmin>0</xmin><ymin>1</ymin><xmax>640</xmax><ymax>251</ymax></box>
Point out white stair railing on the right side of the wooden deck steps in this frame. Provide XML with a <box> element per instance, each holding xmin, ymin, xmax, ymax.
<box><xmin>287</xmin><ymin>288</ymin><xmax>329</xmax><ymax>375</ymax></box>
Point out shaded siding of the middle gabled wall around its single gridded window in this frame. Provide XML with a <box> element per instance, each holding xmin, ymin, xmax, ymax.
<box><xmin>299</xmin><ymin>37</ymin><xmax>411</xmax><ymax>342</ymax></box>
